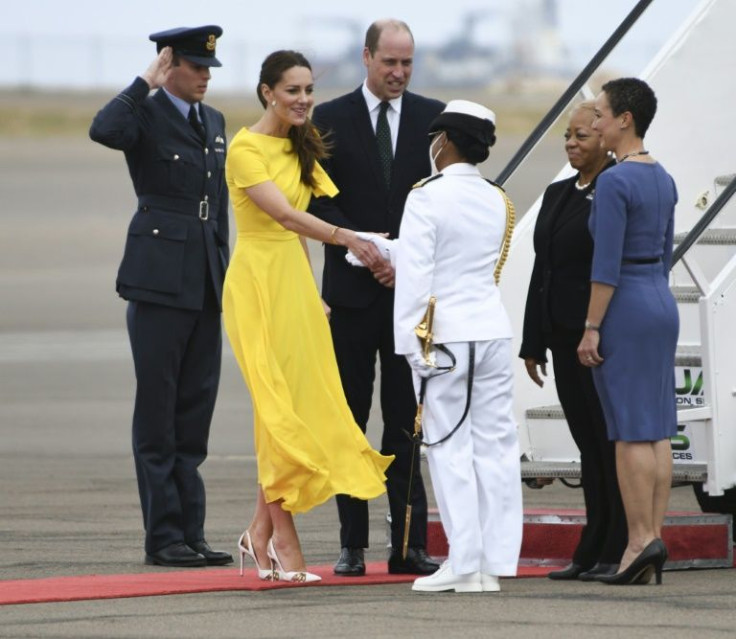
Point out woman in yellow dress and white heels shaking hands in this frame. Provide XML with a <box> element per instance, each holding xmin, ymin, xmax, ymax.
<box><xmin>223</xmin><ymin>51</ymin><xmax>393</xmax><ymax>582</ymax></box>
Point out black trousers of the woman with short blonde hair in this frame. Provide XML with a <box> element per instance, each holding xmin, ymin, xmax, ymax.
<box><xmin>548</xmin><ymin>330</ymin><xmax>628</xmax><ymax>568</ymax></box>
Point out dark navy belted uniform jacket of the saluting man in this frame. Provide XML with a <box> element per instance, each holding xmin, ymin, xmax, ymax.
<box><xmin>90</xmin><ymin>78</ymin><xmax>229</xmax><ymax>310</ymax></box>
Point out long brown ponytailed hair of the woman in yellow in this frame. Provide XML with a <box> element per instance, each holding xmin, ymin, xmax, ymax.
<box><xmin>256</xmin><ymin>50</ymin><xmax>328</xmax><ymax>188</ymax></box>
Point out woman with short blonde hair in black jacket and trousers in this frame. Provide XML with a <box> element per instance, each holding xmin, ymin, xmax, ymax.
<box><xmin>519</xmin><ymin>101</ymin><xmax>627</xmax><ymax>580</ymax></box>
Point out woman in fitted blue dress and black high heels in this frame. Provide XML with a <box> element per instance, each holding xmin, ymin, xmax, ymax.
<box><xmin>578</xmin><ymin>78</ymin><xmax>679</xmax><ymax>584</ymax></box>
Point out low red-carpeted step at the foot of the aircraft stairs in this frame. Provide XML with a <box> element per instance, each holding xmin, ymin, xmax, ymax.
<box><xmin>427</xmin><ymin>509</ymin><xmax>733</xmax><ymax>570</ymax></box>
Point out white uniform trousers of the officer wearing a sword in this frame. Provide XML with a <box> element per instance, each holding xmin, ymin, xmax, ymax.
<box><xmin>414</xmin><ymin>339</ymin><xmax>523</xmax><ymax>576</ymax></box>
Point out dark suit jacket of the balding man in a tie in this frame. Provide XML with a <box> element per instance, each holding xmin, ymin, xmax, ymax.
<box><xmin>309</xmin><ymin>87</ymin><xmax>444</xmax><ymax>308</ymax></box>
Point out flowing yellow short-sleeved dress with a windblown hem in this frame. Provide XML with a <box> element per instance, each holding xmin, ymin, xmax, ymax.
<box><xmin>222</xmin><ymin>128</ymin><xmax>393</xmax><ymax>513</ymax></box>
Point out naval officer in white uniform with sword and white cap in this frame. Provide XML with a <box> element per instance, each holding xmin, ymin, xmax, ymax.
<box><xmin>394</xmin><ymin>100</ymin><xmax>523</xmax><ymax>592</ymax></box>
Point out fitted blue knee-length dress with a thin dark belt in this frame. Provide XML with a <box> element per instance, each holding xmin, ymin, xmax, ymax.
<box><xmin>590</xmin><ymin>162</ymin><xmax>680</xmax><ymax>442</ymax></box>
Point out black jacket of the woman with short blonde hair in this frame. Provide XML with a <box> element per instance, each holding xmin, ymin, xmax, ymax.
<box><xmin>519</xmin><ymin>163</ymin><xmax>613</xmax><ymax>362</ymax></box>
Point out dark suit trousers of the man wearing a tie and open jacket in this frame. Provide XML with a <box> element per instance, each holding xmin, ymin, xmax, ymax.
<box><xmin>330</xmin><ymin>289</ymin><xmax>427</xmax><ymax>548</ymax></box>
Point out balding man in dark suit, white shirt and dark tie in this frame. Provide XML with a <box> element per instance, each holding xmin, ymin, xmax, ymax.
<box><xmin>310</xmin><ymin>20</ymin><xmax>444</xmax><ymax>576</ymax></box>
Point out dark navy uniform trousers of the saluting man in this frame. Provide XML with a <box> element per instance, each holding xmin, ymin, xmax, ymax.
<box><xmin>127</xmin><ymin>284</ymin><xmax>222</xmax><ymax>553</ymax></box>
